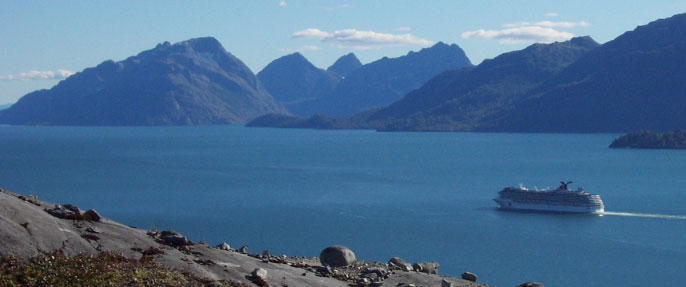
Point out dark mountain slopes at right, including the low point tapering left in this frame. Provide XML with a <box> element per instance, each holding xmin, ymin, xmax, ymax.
<box><xmin>248</xmin><ymin>14</ymin><xmax>686</xmax><ymax>132</ymax></box>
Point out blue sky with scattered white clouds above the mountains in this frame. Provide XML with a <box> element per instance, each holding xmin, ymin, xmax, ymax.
<box><xmin>0</xmin><ymin>0</ymin><xmax>686</xmax><ymax>104</ymax></box>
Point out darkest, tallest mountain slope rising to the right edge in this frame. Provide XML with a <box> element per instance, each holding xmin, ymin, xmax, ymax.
<box><xmin>498</xmin><ymin>14</ymin><xmax>686</xmax><ymax>132</ymax></box>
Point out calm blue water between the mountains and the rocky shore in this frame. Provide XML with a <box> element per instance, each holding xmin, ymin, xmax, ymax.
<box><xmin>0</xmin><ymin>126</ymin><xmax>686</xmax><ymax>286</ymax></box>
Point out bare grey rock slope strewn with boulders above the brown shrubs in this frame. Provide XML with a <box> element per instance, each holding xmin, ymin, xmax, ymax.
<box><xmin>0</xmin><ymin>189</ymin><xmax>534</xmax><ymax>287</ymax></box>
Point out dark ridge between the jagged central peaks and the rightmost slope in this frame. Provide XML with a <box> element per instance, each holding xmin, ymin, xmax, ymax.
<box><xmin>368</xmin><ymin>37</ymin><xmax>598</xmax><ymax>131</ymax></box>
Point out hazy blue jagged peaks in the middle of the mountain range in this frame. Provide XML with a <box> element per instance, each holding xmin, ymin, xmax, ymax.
<box><xmin>257</xmin><ymin>42</ymin><xmax>471</xmax><ymax>117</ymax></box>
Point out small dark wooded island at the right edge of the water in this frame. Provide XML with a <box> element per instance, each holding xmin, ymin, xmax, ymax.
<box><xmin>610</xmin><ymin>130</ymin><xmax>686</xmax><ymax>149</ymax></box>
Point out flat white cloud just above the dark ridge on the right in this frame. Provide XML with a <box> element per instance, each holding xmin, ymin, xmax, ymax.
<box><xmin>462</xmin><ymin>26</ymin><xmax>574</xmax><ymax>44</ymax></box>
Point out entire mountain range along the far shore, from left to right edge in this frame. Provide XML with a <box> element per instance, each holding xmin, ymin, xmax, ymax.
<box><xmin>5</xmin><ymin>14</ymin><xmax>686</xmax><ymax>132</ymax></box>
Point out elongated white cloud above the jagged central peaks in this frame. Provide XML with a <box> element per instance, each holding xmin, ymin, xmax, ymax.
<box><xmin>291</xmin><ymin>28</ymin><xmax>433</xmax><ymax>50</ymax></box>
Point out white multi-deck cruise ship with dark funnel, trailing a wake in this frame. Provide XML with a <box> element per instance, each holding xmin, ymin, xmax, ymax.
<box><xmin>493</xmin><ymin>181</ymin><xmax>605</xmax><ymax>214</ymax></box>
